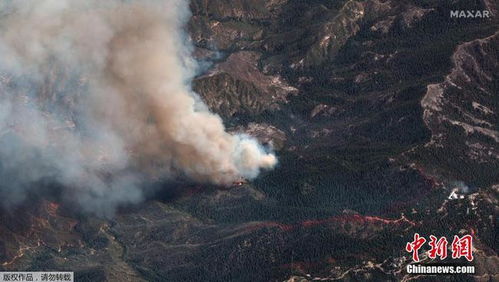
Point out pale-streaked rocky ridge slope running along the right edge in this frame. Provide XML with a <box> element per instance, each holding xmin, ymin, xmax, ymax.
<box><xmin>421</xmin><ymin>33</ymin><xmax>499</xmax><ymax>185</ymax></box>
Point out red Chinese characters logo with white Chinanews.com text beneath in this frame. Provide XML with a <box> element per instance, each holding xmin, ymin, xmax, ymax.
<box><xmin>405</xmin><ymin>233</ymin><xmax>475</xmax><ymax>275</ymax></box>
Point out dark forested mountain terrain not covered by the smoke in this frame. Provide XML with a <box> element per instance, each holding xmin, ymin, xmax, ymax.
<box><xmin>0</xmin><ymin>0</ymin><xmax>499</xmax><ymax>281</ymax></box>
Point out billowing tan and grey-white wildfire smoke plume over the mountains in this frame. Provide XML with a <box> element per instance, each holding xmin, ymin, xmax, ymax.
<box><xmin>0</xmin><ymin>0</ymin><xmax>276</xmax><ymax>214</ymax></box>
